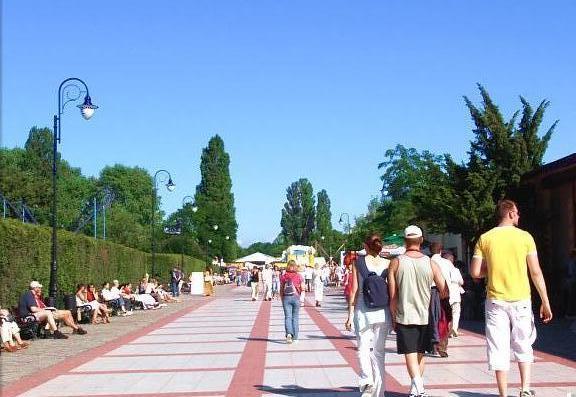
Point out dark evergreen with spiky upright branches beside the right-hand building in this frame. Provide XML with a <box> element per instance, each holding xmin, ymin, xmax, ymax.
<box><xmin>437</xmin><ymin>84</ymin><xmax>558</xmax><ymax>246</ymax></box>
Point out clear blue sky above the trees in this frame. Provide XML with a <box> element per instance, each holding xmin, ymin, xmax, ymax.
<box><xmin>1</xmin><ymin>0</ymin><xmax>576</xmax><ymax>245</ymax></box>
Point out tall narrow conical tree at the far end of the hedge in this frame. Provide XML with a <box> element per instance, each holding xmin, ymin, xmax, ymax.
<box><xmin>194</xmin><ymin>135</ymin><xmax>238</xmax><ymax>260</ymax></box>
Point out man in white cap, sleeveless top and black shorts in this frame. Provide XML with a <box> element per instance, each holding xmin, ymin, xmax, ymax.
<box><xmin>388</xmin><ymin>225</ymin><xmax>448</xmax><ymax>397</ymax></box>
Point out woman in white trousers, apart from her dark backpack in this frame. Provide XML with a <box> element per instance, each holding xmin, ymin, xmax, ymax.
<box><xmin>345</xmin><ymin>233</ymin><xmax>392</xmax><ymax>397</ymax></box>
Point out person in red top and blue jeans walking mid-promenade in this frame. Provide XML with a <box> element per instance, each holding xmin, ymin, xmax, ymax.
<box><xmin>280</xmin><ymin>260</ymin><xmax>306</xmax><ymax>344</ymax></box>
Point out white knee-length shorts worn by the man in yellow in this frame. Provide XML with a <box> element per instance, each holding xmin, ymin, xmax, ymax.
<box><xmin>485</xmin><ymin>299</ymin><xmax>536</xmax><ymax>371</ymax></box>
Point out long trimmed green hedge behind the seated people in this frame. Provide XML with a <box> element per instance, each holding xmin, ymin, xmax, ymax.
<box><xmin>0</xmin><ymin>219</ymin><xmax>205</xmax><ymax>307</ymax></box>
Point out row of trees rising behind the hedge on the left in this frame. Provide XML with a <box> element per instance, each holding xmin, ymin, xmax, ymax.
<box><xmin>0</xmin><ymin>131</ymin><xmax>239</xmax><ymax>259</ymax></box>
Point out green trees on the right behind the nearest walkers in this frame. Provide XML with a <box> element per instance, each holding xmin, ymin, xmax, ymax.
<box><xmin>344</xmin><ymin>84</ymin><xmax>558</xmax><ymax>254</ymax></box>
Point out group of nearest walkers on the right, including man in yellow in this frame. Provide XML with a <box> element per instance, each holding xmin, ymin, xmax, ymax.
<box><xmin>343</xmin><ymin>200</ymin><xmax>552</xmax><ymax>397</ymax></box>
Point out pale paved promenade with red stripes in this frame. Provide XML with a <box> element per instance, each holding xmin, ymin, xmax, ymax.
<box><xmin>2</xmin><ymin>286</ymin><xmax>576</xmax><ymax>397</ymax></box>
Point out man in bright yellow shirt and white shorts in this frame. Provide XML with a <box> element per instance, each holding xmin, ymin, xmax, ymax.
<box><xmin>470</xmin><ymin>200</ymin><xmax>552</xmax><ymax>397</ymax></box>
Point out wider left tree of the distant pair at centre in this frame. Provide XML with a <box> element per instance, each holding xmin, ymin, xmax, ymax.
<box><xmin>280</xmin><ymin>178</ymin><xmax>315</xmax><ymax>245</ymax></box>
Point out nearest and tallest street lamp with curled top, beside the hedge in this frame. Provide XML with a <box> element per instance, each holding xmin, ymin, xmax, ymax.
<box><xmin>49</xmin><ymin>77</ymin><xmax>98</xmax><ymax>306</ymax></box>
